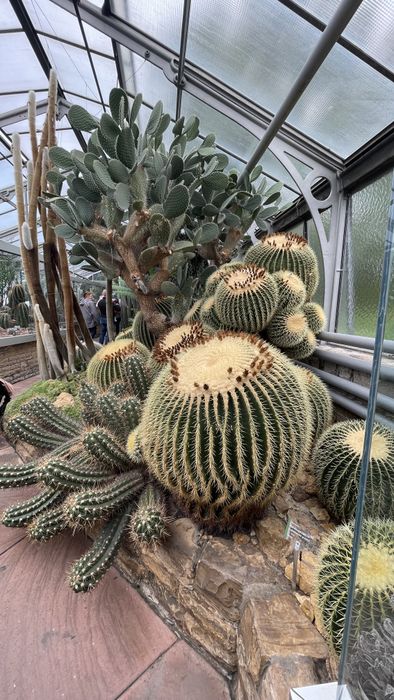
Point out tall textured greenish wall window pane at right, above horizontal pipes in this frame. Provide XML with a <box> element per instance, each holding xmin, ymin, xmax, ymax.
<box><xmin>337</xmin><ymin>172</ymin><xmax>394</xmax><ymax>339</ymax></box>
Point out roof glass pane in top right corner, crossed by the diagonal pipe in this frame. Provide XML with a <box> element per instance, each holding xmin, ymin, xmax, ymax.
<box><xmin>290</xmin><ymin>0</ymin><xmax>394</xmax><ymax>69</ymax></box>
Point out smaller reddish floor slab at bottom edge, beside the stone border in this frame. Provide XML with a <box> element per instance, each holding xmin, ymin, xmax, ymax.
<box><xmin>120</xmin><ymin>641</ymin><xmax>230</xmax><ymax>700</ymax></box>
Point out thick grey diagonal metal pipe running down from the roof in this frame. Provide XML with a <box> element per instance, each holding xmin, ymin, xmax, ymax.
<box><xmin>238</xmin><ymin>0</ymin><xmax>362</xmax><ymax>185</ymax></box>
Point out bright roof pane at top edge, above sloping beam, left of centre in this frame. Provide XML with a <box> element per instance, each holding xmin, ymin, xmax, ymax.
<box><xmin>111</xmin><ymin>0</ymin><xmax>183</xmax><ymax>51</ymax></box>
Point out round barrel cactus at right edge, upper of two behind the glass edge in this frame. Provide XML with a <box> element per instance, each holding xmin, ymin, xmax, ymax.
<box><xmin>313</xmin><ymin>420</ymin><xmax>394</xmax><ymax>520</ymax></box>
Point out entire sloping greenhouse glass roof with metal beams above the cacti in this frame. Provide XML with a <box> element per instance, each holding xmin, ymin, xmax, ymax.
<box><xmin>0</xmin><ymin>0</ymin><xmax>394</xmax><ymax>260</ymax></box>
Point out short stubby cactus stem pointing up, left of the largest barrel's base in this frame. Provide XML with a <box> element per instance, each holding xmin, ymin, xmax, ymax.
<box><xmin>129</xmin><ymin>484</ymin><xmax>168</xmax><ymax>545</ymax></box>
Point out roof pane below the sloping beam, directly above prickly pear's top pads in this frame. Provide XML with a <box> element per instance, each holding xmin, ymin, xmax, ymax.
<box><xmin>118</xmin><ymin>44</ymin><xmax>176</xmax><ymax>117</ymax></box>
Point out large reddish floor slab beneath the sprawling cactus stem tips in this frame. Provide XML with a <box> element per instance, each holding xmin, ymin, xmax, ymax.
<box><xmin>0</xmin><ymin>535</ymin><xmax>176</xmax><ymax>700</ymax></box>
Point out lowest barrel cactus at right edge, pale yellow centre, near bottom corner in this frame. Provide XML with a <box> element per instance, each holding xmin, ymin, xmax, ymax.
<box><xmin>316</xmin><ymin>519</ymin><xmax>394</xmax><ymax>654</ymax></box>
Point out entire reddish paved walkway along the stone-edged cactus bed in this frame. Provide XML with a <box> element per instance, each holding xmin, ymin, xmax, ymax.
<box><xmin>0</xmin><ymin>380</ymin><xmax>230</xmax><ymax>700</ymax></box>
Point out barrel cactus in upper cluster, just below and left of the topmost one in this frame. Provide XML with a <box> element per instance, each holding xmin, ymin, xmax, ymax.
<box><xmin>212</xmin><ymin>265</ymin><xmax>278</xmax><ymax>333</ymax></box>
